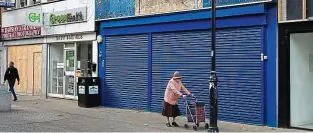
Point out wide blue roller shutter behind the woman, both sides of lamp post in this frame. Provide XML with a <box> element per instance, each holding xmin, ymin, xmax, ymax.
<box><xmin>151</xmin><ymin>27</ymin><xmax>263</xmax><ymax>125</ymax></box>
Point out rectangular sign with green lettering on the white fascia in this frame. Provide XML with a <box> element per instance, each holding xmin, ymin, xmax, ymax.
<box><xmin>50</xmin><ymin>8</ymin><xmax>87</xmax><ymax>25</ymax></box>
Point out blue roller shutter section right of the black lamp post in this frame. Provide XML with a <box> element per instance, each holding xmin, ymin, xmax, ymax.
<box><xmin>216</xmin><ymin>27</ymin><xmax>263</xmax><ymax>125</ymax></box>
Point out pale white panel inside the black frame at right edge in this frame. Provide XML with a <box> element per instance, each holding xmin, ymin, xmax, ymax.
<box><xmin>290</xmin><ymin>33</ymin><xmax>313</xmax><ymax>127</ymax></box>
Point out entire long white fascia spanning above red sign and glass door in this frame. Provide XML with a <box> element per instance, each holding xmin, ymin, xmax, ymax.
<box><xmin>2</xmin><ymin>0</ymin><xmax>95</xmax><ymax>35</ymax></box>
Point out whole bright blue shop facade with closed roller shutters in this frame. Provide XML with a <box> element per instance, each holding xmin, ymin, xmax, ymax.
<box><xmin>96</xmin><ymin>2</ymin><xmax>277</xmax><ymax>127</ymax></box>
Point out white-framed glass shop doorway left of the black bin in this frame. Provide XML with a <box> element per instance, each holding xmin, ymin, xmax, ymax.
<box><xmin>48</xmin><ymin>43</ymin><xmax>77</xmax><ymax>99</ymax></box>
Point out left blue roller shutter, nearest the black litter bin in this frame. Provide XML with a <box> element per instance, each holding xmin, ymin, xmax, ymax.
<box><xmin>104</xmin><ymin>35</ymin><xmax>148</xmax><ymax>110</ymax></box>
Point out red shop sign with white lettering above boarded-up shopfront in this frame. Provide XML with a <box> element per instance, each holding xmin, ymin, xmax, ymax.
<box><xmin>1</xmin><ymin>25</ymin><xmax>41</xmax><ymax>40</ymax></box>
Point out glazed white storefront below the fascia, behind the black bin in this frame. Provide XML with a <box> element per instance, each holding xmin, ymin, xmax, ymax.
<box><xmin>47</xmin><ymin>33</ymin><xmax>97</xmax><ymax>99</ymax></box>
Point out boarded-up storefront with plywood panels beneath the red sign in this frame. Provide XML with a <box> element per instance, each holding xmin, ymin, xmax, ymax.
<box><xmin>1</xmin><ymin>6</ymin><xmax>44</xmax><ymax>96</ymax></box>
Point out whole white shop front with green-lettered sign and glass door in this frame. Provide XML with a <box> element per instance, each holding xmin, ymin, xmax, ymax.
<box><xmin>43</xmin><ymin>0</ymin><xmax>98</xmax><ymax>99</ymax></box>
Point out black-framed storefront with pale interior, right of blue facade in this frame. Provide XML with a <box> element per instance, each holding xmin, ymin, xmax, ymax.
<box><xmin>278</xmin><ymin>21</ymin><xmax>313</xmax><ymax>130</ymax></box>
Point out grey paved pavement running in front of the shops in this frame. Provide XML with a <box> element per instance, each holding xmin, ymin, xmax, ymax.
<box><xmin>0</xmin><ymin>96</ymin><xmax>301</xmax><ymax>132</ymax></box>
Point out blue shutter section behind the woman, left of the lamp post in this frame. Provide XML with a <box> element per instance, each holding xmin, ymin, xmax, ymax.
<box><xmin>151</xmin><ymin>30</ymin><xmax>211</xmax><ymax>117</ymax></box>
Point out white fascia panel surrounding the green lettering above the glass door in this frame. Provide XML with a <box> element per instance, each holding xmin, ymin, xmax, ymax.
<box><xmin>42</xmin><ymin>0</ymin><xmax>95</xmax><ymax>35</ymax></box>
